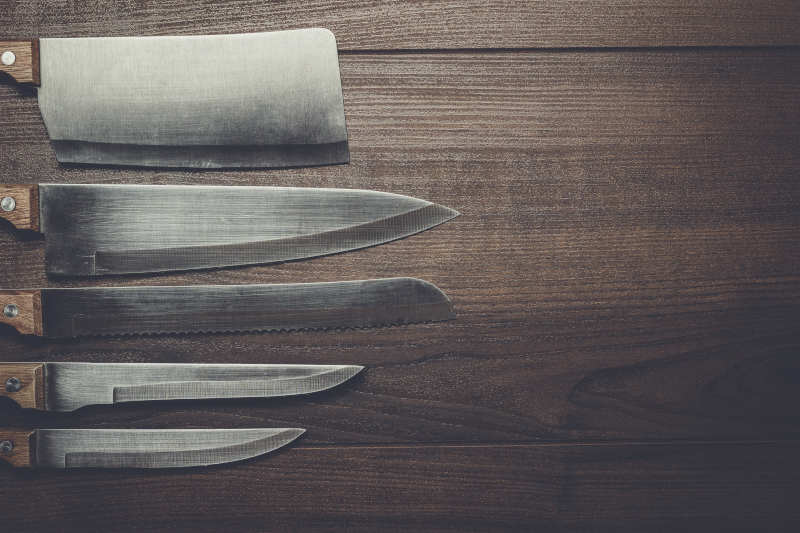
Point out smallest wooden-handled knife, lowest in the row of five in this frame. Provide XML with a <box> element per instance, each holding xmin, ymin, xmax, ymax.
<box><xmin>0</xmin><ymin>428</ymin><xmax>305</xmax><ymax>468</ymax></box>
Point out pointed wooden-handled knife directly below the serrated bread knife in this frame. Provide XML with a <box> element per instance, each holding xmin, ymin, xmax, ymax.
<box><xmin>0</xmin><ymin>363</ymin><xmax>364</xmax><ymax>411</ymax></box>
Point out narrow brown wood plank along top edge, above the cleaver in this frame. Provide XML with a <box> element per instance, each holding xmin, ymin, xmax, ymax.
<box><xmin>0</xmin><ymin>0</ymin><xmax>800</xmax><ymax>50</ymax></box>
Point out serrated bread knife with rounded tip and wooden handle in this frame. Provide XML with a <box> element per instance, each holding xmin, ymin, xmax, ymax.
<box><xmin>0</xmin><ymin>278</ymin><xmax>454</xmax><ymax>338</ymax></box>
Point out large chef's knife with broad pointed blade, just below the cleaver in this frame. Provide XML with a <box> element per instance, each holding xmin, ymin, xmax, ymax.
<box><xmin>0</xmin><ymin>184</ymin><xmax>458</xmax><ymax>276</ymax></box>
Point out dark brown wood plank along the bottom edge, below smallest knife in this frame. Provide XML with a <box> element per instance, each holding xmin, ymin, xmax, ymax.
<box><xmin>0</xmin><ymin>442</ymin><xmax>800</xmax><ymax>532</ymax></box>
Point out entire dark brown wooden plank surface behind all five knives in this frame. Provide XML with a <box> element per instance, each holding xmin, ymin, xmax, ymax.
<box><xmin>0</xmin><ymin>0</ymin><xmax>800</xmax><ymax>531</ymax></box>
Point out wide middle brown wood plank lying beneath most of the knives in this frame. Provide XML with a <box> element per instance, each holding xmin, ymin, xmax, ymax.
<box><xmin>0</xmin><ymin>50</ymin><xmax>800</xmax><ymax>443</ymax></box>
